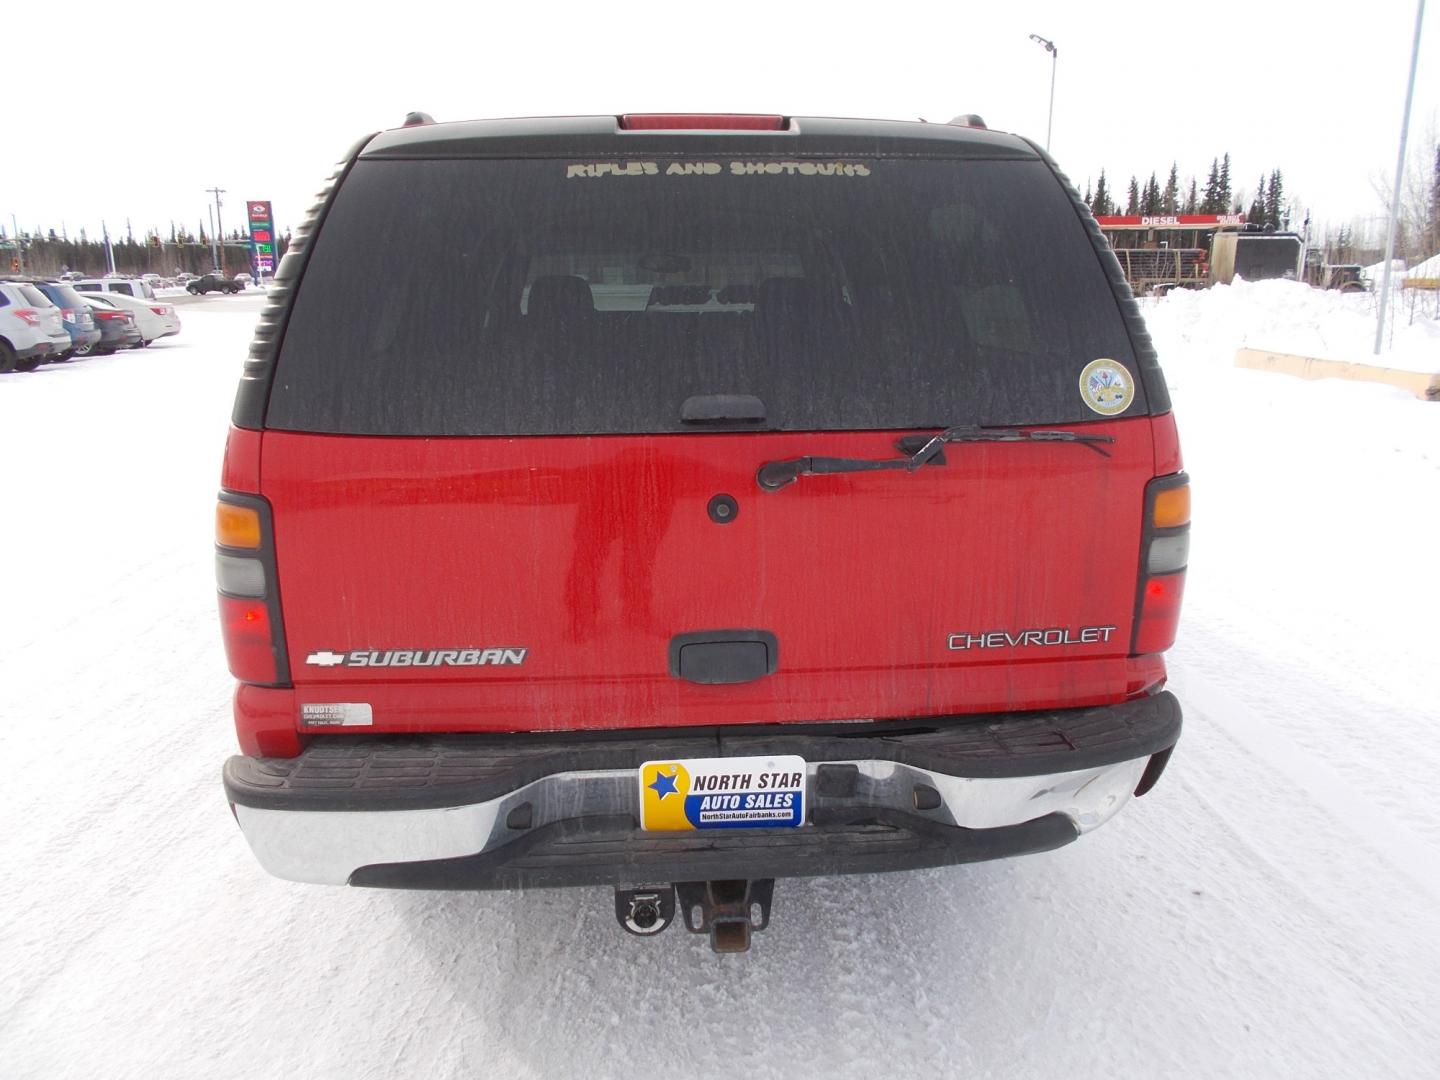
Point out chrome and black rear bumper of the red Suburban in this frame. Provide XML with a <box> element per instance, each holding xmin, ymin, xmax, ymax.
<box><xmin>225</xmin><ymin>694</ymin><xmax>1179</xmax><ymax>888</ymax></box>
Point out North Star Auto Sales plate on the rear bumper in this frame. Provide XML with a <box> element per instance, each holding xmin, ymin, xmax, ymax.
<box><xmin>639</xmin><ymin>755</ymin><xmax>805</xmax><ymax>831</ymax></box>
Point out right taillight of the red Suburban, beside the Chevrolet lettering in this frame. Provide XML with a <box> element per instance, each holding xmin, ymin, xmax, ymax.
<box><xmin>1130</xmin><ymin>472</ymin><xmax>1189</xmax><ymax>655</ymax></box>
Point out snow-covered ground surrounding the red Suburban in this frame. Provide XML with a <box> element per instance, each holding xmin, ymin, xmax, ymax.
<box><xmin>0</xmin><ymin>287</ymin><xmax>1440</xmax><ymax>1080</ymax></box>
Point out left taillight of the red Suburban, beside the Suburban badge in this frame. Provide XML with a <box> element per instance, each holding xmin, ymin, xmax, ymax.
<box><xmin>215</xmin><ymin>491</ymin><xmax>289</xmax><ymax>685</ymax></box>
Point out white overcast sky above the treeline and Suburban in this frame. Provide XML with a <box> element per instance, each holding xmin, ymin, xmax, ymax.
<box><xmin>0</xmin><ymin>0</ymin><xmax>1440</xmax><ymax>238</ymax></box>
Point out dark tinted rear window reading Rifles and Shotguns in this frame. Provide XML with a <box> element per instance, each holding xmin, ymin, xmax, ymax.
<box><xmin>266</xmin><ymin>157</ymin><xmax>1145</xmax><ymax>435</ymax></box>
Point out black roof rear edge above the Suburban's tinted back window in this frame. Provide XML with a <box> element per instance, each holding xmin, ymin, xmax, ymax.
<box><xmin>360</xmin><ymin>115</ymin><xmax>1040</xmax><ymax>158</ymax></box>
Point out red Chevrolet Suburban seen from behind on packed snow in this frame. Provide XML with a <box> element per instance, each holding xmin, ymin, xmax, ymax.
<box><xmin>218</xmin><ymin>114</ymin><xmax>1189</xmax><ymax>950</ymax></box>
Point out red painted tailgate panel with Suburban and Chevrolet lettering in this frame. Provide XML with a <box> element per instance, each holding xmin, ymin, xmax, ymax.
<box><xmin>262</xmin><ymin>419</ymin><xmax>1162</xmax><ymax>732</ymax></box>
